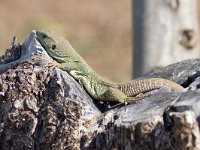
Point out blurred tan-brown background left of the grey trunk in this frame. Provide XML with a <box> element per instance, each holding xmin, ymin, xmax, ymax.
<box><xmin>0</xmin><ymin>0</ymin><xmax>132</xmax><ymax>82</ymax></box>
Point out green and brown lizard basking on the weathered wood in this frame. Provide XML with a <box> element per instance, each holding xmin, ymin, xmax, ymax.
<box><xmin>34</xmin><ymin>30</ymin><xmax>183</xmax><ymax>103</ymax></box>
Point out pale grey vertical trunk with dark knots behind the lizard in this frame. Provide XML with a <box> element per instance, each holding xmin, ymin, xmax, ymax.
<box><xmin>133</xmin><ymin>0</ymin><xmax>200</xmax><ymax>77</ymax></box>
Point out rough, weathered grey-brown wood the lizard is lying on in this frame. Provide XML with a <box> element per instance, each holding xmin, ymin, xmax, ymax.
<box><xmin>0</xmin><ymin>33</ymin><xmax>200</xmax><ymax>150</ymax></box>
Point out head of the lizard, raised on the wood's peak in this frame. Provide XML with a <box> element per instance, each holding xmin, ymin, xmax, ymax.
<box><xmin>35</xmin><ymin>30</ymin><xmax>72</xmax><ymax>63</ymax></box>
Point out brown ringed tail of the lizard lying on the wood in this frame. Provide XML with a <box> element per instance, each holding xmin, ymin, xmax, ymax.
<box><xmin>118</xmin><ymin>78</ymin><xmax>184</xmax><ymax>97</ymax></box>
